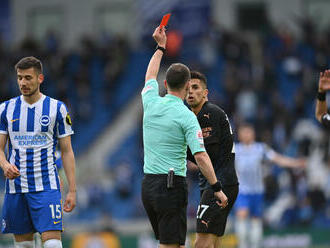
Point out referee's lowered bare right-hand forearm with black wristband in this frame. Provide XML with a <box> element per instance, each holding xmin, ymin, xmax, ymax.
<box><xmin>194</xmin><ymin>152</ymin><xmax>228</xmax><ymax>208</ymax></box>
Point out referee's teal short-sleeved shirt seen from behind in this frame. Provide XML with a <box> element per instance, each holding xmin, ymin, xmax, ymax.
<box><xmin>141</xmin><ymin>79</ymin><xmax>205</xmax><ymax>177</ymax></box>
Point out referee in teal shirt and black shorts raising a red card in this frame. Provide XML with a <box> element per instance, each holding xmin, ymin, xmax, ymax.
<box><xmin>141</xmin><ymin>27</ymin><xmax>227</xmax><ymax>248</ymax></box>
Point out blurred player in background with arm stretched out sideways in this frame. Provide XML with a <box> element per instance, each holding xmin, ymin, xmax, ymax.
<box><xmin>235</xmin><ymin>124</ymin><xmax>306</xmax><ymax>248</ymax></box>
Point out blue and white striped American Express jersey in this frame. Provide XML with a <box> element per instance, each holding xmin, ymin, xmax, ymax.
<box><xmin>0</xmin><ymin>95</ymin><xmax>73</xmax><ymax>194</ymax></box>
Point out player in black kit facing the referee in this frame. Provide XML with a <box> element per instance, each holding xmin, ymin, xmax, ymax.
<box><xmin>186</xmin><ymin>71</ymin><xmax>238</xmax><ymax>248</ymax></box>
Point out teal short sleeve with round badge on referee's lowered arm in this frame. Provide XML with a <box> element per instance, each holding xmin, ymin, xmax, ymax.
<box><xmin>183</xmin><ymin>110</ymin><xmax>205</xmax><ymax>155</ymax></box>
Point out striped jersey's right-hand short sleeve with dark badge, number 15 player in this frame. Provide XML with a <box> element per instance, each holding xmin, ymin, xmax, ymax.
<box><xmin>57</xmin><ymin>103</ymin><xmax>74</xmax><ymax>138</ymax></box>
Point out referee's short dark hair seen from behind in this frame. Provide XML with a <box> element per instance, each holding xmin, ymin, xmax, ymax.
<box><xmin>166</xmin><ymin>63</ymin><xmax>190</xmax><ymax>90</ymax></box>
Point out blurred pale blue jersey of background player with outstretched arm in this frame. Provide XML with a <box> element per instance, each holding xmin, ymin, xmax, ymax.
<box><xmin>235</xmin><ymin>142</ymin><xmax>276</xmax><ymax>194</ymax></box>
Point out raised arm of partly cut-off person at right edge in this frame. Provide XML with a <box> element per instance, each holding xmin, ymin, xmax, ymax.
<box><xmin>315</xmin><ymin>70</ymin><xmax>330</xmax><ymax>128</ymax></box>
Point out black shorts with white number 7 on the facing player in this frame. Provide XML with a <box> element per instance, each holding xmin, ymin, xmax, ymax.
<box><xmin>196</xmin><ymin>185</ymin><xmax>238</xmax><ymax>236</ymax></box>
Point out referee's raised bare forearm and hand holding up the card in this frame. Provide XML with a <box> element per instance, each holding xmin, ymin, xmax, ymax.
<box><xmin>145</xmin><ymin>27</ymin><xmax>166</xmax><ymax>82</ymax></box>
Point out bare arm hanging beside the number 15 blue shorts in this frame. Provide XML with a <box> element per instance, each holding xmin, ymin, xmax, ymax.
<box><xmin>59</xmin><ymin>135</ymin><xmax>76</xmax><ymax>212</ymax></box>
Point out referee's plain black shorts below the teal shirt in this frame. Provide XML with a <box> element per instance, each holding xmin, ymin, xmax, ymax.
<box><xmin>142</xmin><ymin>174</ymin><xmax>188</xmax><ymax>245</ymax></box>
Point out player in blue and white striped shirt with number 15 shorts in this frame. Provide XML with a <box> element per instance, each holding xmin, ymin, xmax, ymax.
<box><xmin>0</xmin><ymin>57</ymin><xmax>76</xmax><ymax>248</ymax></box>
